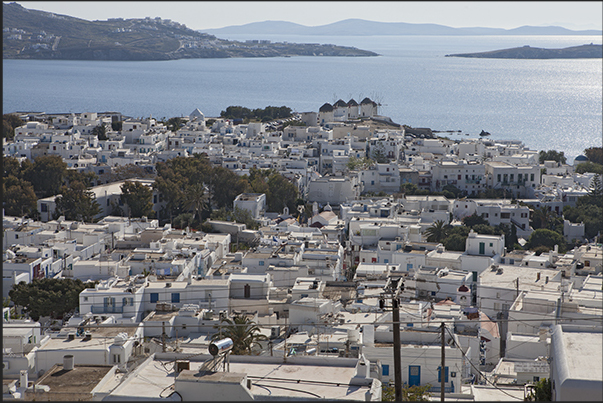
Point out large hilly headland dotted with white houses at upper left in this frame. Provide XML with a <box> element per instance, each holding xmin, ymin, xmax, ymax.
<box><xmin>2</xmin><ymin>3</ymin><xmax>378</xmax><ymax>61</ymax></box>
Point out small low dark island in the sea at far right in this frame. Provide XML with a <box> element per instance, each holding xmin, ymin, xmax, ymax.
<box><xmin>446</xmin><ymin>43</ymin><xmax>603</xmax><ymax>59</ymax></box>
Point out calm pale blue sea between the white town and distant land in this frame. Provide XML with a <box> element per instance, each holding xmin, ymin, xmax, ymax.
<box><xmin>2</xmin><ymin>35</ymin><xmax>603</xmax><ymax>164</ymax></box>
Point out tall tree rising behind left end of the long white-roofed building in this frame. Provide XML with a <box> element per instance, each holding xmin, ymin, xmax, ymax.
<box><xmin>21</xmin><ymin>155</ymin><xmax>67</xmax><ymax>198</ymax></box>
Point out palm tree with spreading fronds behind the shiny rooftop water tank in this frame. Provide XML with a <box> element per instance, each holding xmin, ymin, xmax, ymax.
<box><xmin>211</xmin><ymin>315</ymin><xmax>268</xmax><ymax>355</ymax></box>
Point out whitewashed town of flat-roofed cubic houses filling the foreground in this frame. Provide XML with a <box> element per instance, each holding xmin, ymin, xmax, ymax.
<box><xmin>2</xmin><ymin>97</ymin><xmax>603</xmax><ymax>401</ymax></box>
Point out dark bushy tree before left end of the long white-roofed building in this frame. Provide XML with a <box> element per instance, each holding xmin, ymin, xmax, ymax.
<box><xmin>54</xmin><ymin>182</ymin><xmax>101</xmax><ymax>222</ymax></box>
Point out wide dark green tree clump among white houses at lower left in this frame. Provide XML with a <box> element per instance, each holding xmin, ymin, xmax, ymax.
<box><xmin>8</xmin><ymin>278</ymin><xmax>94</xmax><ymax>321</ymax></box>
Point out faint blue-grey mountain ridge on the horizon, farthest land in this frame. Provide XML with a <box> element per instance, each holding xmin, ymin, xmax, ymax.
<box><xmin>199</xmin><ymin>19</ymin><xmax>603</xmax><ymax>36</ymax></box>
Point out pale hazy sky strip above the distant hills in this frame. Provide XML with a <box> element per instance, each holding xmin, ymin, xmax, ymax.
<box><xmin>17</xmin><ymin>1</ymin><xmax>603</xmax><ymax>30</ymax></box>
